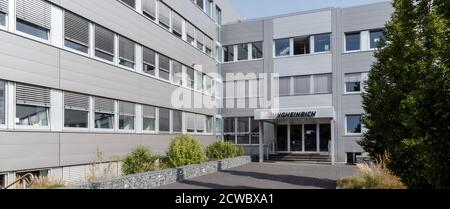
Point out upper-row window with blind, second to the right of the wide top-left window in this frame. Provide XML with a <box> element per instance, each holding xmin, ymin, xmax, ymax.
<box><xmin>95</xmin><ymin>25</ymin><xmax>115</xmax><ymax>62</ymax></box>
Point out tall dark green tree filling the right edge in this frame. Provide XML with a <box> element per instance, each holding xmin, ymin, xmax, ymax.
<box><xmin>360</xmin><ymin>0</ymin><xmax>450</xmax><ymax>188</ymax></box>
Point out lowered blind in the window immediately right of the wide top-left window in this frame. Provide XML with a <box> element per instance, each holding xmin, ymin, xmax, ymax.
<box><xmin>64</xmin><ymin>11</ymin><xmax>89</xmax><ymax>46</ymax></box>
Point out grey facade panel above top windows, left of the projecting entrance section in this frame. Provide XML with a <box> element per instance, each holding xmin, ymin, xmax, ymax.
<box><xmin>222</xmin><ymin>21</ymin><xmax>263</xmax><ymax>46</ymax></box>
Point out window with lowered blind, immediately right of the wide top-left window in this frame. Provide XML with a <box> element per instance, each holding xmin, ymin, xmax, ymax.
<box><xmin>64</xmin><ymin>11</ymin><xmax>89</xmax><ymax>53</ymax></box>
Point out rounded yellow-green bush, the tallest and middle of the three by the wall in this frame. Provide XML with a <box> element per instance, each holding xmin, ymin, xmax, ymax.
<box><xmin>167</xmin><ymin>135</ymin><xmax>205</xmax><ymax>168</ymax></box>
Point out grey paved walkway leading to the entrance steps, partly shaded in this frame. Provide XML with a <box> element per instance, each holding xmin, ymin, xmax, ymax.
<box><xmin>160</xmin><ymin>163</ymin><xmax>358</xmax><ymax>189</ymax></box>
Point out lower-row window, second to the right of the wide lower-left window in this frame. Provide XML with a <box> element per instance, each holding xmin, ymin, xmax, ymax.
<box><xmin>94</xmin><ymin>97</ymin><xmax>115</xmax><ymax>129</ymax></box>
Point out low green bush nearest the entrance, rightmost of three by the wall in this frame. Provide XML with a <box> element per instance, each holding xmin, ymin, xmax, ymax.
<box><xmin>206</xmin><ymin>141</ymin><xmax>244</xmax><ymax>160</ymax></box>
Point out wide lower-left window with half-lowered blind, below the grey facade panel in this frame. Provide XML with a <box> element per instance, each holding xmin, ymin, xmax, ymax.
<box><xmin>16</xmin><ymin>83</ymin><xmax>50</xmax><ymax>127</ymax></box>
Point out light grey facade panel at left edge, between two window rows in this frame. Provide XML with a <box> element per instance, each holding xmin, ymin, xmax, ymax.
<box><xmin>0</xmin><ymin>30</ymin><xmax>59</xmax><ymax>88</ymax></box>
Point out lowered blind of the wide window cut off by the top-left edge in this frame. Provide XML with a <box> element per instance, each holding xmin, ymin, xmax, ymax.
<box><xmin>16</xmin><ymin>0</ymin><xmax>51</xmax><ymax>30</ymax></box>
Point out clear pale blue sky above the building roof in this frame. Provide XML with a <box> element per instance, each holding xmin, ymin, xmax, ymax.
<box><xmin>231</xmin><ymin>0</ymin><xmax>389</xmax><ymax>19</ymax></box>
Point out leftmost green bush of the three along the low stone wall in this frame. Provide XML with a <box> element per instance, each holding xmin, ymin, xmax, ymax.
<box><xmin>122</xmin><ymin>146</ymin><xmax>158</xmax><ymax>175</ymax></box>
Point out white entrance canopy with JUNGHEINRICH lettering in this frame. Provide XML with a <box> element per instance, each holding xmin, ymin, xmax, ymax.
<box><xmin>255</xmin><ymin>107</ymin><xmax>335</xmax><ymax>122</ymax></box>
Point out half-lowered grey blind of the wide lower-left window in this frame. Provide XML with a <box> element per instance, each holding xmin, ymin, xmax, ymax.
<box><xmin>16</xmin><ymin>83</ymin><xmax>50</xmax><ymax>107</ymax></box>
